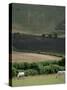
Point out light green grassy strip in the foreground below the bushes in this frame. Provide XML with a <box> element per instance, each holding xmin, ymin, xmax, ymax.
<box><xmin>12</xmin><ymin>74</ymin><xmax>65</xmax><ymax>86</ymax></box>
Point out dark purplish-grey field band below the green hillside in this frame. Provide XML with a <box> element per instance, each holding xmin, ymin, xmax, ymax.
<box><xmin>12</xmin><ymin>33</ymin><xmax>65</xmax><ymax>53</ymax></box>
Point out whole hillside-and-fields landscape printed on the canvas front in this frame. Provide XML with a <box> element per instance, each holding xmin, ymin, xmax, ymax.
<box><xmin>9</xmin><ymin>4</ymin><xmax>65</xmax><ymax>86</ymax></box>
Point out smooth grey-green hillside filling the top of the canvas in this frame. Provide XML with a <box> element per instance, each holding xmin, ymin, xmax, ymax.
<box><xmin>12</xmin><ymin>4</ymin><xmax>65</xmax><ymax>34</ymax></box>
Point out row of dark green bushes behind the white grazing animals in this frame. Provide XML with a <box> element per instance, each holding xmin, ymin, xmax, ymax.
<box><xmin>10</xmin><ymin>58</ymin><xmax>65</xmax><ymax>77</ymax></box>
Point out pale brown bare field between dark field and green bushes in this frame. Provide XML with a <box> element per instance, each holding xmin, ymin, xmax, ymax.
<box><xmin>12</xmin><ymin>52</ymin><xmax>61</xmax><ymax>63</ymax></box>
